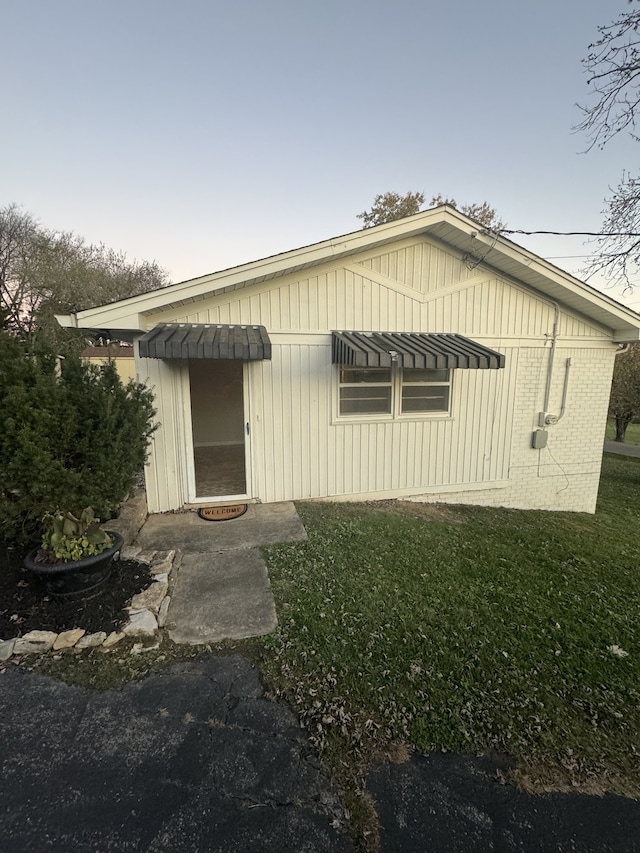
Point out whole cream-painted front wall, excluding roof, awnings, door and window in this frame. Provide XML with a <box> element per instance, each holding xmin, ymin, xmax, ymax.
<box><xmin>139</xmin><ymin>235</ymin><xmax>613</xmax><ymax>511</ymax></box>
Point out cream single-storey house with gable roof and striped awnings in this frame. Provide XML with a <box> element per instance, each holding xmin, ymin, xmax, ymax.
<box><xmin>59</xmin><ymin>205</ymin><xmax>640</xmax><ymax>512</ymax></box>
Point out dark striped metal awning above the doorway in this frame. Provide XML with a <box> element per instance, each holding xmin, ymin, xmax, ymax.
<box><xmin>138</xmin><ymin>323</ymin><xmax>271</xmax><ymax>361</ymax></box>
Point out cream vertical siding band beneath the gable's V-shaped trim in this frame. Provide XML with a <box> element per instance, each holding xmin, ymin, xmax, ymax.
<box><xmin>154</xmin><ymin>272</ymin><xmax>607</xmax><ymax>340</ymax></box>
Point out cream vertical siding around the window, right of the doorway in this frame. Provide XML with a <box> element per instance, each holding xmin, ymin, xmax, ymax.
<box><xmin>248</xmin><ymin>339</ymin><xmax>517</xmax><ymax>502</ymax></box>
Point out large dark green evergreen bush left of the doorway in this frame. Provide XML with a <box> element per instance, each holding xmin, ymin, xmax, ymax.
<box><xmin>0</xmin><ymin>333</ymin><xmax>154</xmax><ymax>541</ymax></box>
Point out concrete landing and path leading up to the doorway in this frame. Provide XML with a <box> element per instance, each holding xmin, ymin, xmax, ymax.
<box><xmin>135</xmin><ymin>503</ymin><xmax>307</xmax><ymax>644</ymax></box>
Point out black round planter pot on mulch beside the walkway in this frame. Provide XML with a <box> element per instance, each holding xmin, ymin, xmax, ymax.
<box><xmin>23</xmin><ymin>530</ymin><xmax>124</xmax><ymax>601</ymax></box>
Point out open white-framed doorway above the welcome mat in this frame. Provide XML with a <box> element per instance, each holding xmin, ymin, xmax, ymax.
<box><xmin>189</xmin><ymin>359</ymin><xmax>247</xmax><ymax>499</ymax></box>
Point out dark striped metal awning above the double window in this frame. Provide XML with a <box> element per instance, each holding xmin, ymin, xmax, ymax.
<box><xmin>331</xmin><ymin>332</ymin><xmax>504</xmax><ymax>370</ymax></box>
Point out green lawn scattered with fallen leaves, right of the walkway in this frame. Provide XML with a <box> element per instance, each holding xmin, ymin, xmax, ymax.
<box><xmin>261</xmin><ymin>458</ymin><xmax>640</xmax><ymax>794</ymax></box>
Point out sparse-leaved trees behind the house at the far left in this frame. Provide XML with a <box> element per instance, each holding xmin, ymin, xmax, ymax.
<box><xmin>0</xmin><ymin>204</ymin><xmax>168</xmax><ymax>350</ymax></box>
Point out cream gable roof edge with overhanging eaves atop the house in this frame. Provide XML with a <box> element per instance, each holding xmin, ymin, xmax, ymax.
<box><xmin>57</xmin><ymin>205</ymin><xmax>640</xmax><ymax>341</ymax></box>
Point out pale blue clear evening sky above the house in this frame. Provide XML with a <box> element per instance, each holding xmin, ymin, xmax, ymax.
<box><xmin>0</xmin><ymin>0</ymin><xmax>640</xmax><ymax>310</ymax></box>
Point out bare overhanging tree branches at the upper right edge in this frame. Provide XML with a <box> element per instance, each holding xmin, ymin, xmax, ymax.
<box><xmin>577</xmin><ymin>0</ymin><xmax>640</xmax><ymax>288</ymax></box>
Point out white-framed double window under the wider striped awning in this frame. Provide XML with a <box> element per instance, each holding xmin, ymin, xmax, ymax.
<box><xmin>339</xmin><ymin>367</ymin><xmax>451</xmax><ymax>417</ymax></box>
